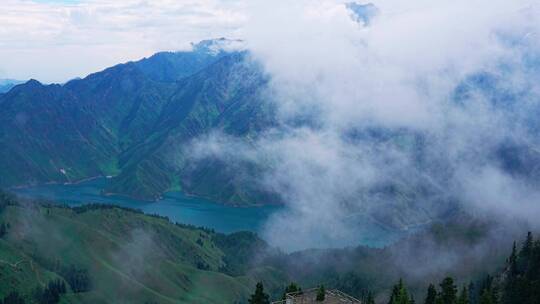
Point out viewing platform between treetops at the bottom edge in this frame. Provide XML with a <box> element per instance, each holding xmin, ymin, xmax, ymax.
<box><xmin>272</xmin><ymin>288</ymin><xmax>362</xmax><ymax>304</ymax></box>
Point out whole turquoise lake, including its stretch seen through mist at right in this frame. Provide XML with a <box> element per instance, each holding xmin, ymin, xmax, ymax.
<box><xmin>12</xmin><ymin>178</ymin><xmax>407</xmax><ymax>250</ymax></box>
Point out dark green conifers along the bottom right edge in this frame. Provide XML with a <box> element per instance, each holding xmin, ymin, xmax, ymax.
<box><xmin>249</xmin><ymin>232</ymin><xmax>540</xmax><ymax>304</ymax></box>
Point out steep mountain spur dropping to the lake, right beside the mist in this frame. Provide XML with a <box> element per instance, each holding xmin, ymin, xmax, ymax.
<box><xmin>103</xmin><ymin>53</ymin><xmax>272</xmax><ymax>203</ymax></box>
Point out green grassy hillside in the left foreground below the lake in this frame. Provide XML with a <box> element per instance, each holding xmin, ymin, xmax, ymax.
<box><xmin>0</xmin><ymin>195</ymin><xmax>281</xmax><ymax>303</ymax></box>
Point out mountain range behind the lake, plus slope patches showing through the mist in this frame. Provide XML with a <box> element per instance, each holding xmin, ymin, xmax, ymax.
<box><xmin>0</xmin><ymin>38</ymin><xmax>540</xmax><ymax>234</ymax></box>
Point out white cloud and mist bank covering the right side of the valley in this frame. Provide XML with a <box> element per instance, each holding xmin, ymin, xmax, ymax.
<box><xmin>182</xmin><ymin>0</ymin><xmax>540</xmax><ymax>251</ymax></box>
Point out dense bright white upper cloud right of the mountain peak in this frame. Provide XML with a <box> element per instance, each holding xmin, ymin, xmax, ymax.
<box><xmin>242</xmin><ymin>0</ymin><xmax>532</xmax><ymax>127</ymax></box>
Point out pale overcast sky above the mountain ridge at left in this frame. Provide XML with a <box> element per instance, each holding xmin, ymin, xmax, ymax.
<box><xmin>0</xmin><ymin>0</ymin><xmax>246</xmax><ymax>82</ymax></box>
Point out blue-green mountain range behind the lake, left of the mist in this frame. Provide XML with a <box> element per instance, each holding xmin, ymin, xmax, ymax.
<box><xmin>0</xmin><ymin>39</ymin><xmax>272</xmax><ymax>204</ymax></box>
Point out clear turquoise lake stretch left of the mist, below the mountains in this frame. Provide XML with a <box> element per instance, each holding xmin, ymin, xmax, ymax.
<box><xmin>12</xmin><ymin>178</ymin><xmax>281</xmax><ymax>233</ymax></box>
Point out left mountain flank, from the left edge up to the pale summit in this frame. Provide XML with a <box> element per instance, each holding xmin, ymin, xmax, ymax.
<box><xmin>0</xmin><ymin>42</ymin><xmax>250</xmax><ymax>198</ymax></box>
